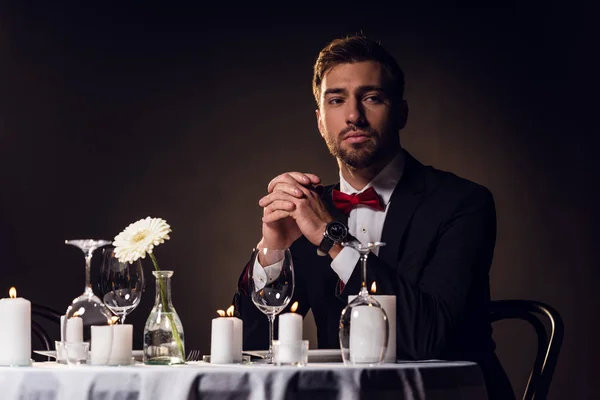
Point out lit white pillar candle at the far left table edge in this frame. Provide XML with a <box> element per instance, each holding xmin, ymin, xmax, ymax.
<box><xmin>0</xmin><ymin>287</ymin><xmax>31</xmax><ymax>365</ymax></box>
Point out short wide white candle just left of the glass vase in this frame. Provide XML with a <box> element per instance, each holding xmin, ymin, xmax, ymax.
<box><xmin>90</xmin><ymin>324</ymin><xmax>133</xmax><ymax>365</ymax></box>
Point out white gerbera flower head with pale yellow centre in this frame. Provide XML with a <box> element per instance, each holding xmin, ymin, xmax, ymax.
<box><xmin>113</xmin><ymin>217</ymin><xmax>171</xmax><ymax>263</ymax></box>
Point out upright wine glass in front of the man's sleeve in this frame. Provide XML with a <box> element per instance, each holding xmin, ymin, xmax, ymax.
<box><xmin>248</xmin><ymin>249</ymin><xmax>294</xmax><ymax>364</ymax></box>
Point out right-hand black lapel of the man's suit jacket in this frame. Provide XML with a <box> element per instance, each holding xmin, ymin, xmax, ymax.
<box><xmin>379</xmin><ymin>152</ymin><xmax>425</xmax><ymax>267</ymax></box>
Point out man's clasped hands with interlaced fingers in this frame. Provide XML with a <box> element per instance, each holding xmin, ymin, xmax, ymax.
<box><xmin>258</xmin><ymin>172</ymin><xmax>333</xmax><ymax>249</ymax></box>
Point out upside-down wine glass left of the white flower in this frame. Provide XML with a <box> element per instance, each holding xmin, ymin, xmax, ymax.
<box><xmin>63</xmin><ymin>239</ymin><xmax>116</xmax><ymax>362</ymax></box>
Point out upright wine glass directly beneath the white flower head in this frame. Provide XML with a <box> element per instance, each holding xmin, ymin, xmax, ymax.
<box><xmin>100</xmin><ymin>246</ymin><xmax>145</xmax><ymax>324</ymax></box>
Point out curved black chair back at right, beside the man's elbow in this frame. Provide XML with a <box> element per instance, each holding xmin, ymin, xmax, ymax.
<box><xmin>490</xmin><ymin>299</ymin><xmax>564</xmax><ymax>400</ymax></box>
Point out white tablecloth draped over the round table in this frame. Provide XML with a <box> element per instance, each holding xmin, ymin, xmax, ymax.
<box><xmin>0</xmin><ymin>362</ymin><xmax>487</xmax><ymax>400</ymax></box>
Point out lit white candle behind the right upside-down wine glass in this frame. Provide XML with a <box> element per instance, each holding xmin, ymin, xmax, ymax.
<box><xmin>348</xmin><ymin>282</ymin><xmax>396</xmax><ymax>363</ymax></box>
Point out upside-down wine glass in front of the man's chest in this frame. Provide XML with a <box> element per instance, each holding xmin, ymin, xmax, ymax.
<box><xmin>339</xmin><ymin>241</ymin><xmax>389</xmax><ymax>364</ymax></box>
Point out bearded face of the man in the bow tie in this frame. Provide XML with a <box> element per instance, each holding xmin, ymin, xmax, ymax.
<box><xmin>317</xmin><ymin>61</ymin><xmax>402</xmax><ymax>169</ymax></box>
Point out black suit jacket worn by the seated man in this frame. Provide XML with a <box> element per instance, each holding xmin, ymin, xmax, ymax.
<box><xmin>234</xmin><ymin>153</ymin><xmax>508</xmax><ymax>398</ymax></box>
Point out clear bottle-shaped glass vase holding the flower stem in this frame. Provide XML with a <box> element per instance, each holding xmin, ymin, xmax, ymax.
<box><xmin>144</xmin><ymin>271</ymin><xmax>185</xmax><ymax>365</ymax></box>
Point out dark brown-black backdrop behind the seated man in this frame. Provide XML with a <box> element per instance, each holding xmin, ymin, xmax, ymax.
<box><xmin>0</xmin><ymin>1</ymin><xmax>600</xmax><ymax>399</ymax></box>
